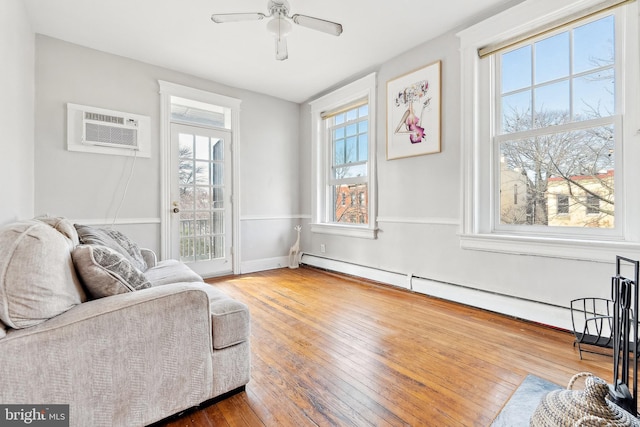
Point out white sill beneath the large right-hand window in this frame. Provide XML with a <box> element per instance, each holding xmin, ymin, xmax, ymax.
<box><xmin>460</xmin><ymin>234</ymin><xmax>640</xmax><ymax>263</ymax></box>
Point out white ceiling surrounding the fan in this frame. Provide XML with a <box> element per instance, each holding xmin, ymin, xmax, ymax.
<box><xmin>24</xmin><ymin>0</ymin><xmax>508</xmax><ymax>102</ymax></box>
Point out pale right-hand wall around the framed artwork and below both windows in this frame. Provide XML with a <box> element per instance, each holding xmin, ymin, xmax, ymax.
<box><xmin>301</xmin><ymin>32</ymin><xmax>615</xmax><ymax>327</ymax></box>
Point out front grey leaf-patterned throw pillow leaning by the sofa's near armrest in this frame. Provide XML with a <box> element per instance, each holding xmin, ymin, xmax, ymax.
<box><xmin>71</xmin><ymin>245</ymin><xmax>151</xmax><ymax>298</ymax></box>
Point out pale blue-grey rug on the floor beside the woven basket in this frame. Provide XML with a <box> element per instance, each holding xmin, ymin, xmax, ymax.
<box><xmin>491</xmin><ymin>374</ymin><xmax>564</xmax><ymax>427</ymax></box>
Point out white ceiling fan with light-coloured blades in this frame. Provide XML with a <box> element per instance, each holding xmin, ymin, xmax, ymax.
<box><xmin>211</xmin><ymin>0</ymin><xmax>342</xmax><ymax>61</ymax></box>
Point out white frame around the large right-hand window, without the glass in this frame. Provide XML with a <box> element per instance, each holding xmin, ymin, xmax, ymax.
<box><xmin>458</xmin><ymin>0</ymin><xmax>640</xmax><ymax>262</ymax></box>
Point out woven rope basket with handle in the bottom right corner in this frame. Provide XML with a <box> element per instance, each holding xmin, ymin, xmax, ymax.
<box><xmin>529</xmin><ymin>372</ymin><xmax>640</xmax><ymax>427</ymax></box>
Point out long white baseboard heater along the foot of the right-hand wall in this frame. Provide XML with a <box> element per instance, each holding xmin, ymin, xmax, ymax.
<box><xmin>302</xmin><ymin>254</ymin><xmax>571</xmax><ymax>330</ymax></box>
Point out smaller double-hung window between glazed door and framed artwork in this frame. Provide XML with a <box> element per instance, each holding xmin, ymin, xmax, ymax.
<box><xmin>311</xmin><ymin>74</ymin><xmax>376</xmax><ymax>238</ymax></box>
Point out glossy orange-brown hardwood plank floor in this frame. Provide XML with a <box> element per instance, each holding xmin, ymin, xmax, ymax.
<box><xmin>158</xmin><ymin>267</ymin><xmax>612</xmax><ymax>427</ymax></box>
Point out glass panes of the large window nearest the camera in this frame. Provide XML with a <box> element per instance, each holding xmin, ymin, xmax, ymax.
<box><xmin>498</xmin><ymin>12</ymin><xmax>622</xmax><ymax>233</ymax></box>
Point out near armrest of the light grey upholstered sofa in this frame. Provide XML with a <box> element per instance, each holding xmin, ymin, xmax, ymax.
<box><xmin>0</xmin><ymin>283</ymin><xmax>214</xmax><ymax>427</ymax></box>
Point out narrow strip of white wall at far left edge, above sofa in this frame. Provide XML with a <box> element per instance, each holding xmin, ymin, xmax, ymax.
<box><xmin>0</xmin><ymin>0</ymin><xmax>35</xmax><ymax>224</ymax></box>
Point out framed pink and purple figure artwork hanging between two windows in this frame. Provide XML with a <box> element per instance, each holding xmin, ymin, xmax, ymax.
<box><xmin>387</xmin><ymin>61</ymin><xmax>441</xmax><ymax>160</ymax></box>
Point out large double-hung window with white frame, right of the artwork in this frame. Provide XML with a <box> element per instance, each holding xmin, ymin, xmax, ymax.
<box><xmin>459</xmin><ymin>0</ymin><xmax>640</xmax><ymax>260</ymax></box>
